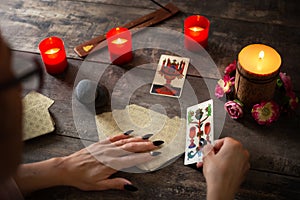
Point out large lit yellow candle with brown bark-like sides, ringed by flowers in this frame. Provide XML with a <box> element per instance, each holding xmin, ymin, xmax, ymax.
<box><xmin>235</xmin><ymin>44</ymin><xmax>281</xmax><ymax>106</ymax></box>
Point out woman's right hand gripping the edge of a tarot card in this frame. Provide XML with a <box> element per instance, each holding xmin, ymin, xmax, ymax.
<box><xmin>198</xmin><ymin>137</ymin><xmax>250</xmax><ymax>200</ymax></box>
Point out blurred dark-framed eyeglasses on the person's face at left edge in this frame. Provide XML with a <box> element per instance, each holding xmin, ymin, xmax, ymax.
<box><xmin>0</xmin><ymin>56</ymin><xmax>44</xmax><ymax>92</ymax></box>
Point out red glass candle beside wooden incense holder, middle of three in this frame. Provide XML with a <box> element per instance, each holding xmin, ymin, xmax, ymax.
<box><xmin>106</xmin><ymin>27</ymin><xmax>132</xmax><ymax>65</ymax></box>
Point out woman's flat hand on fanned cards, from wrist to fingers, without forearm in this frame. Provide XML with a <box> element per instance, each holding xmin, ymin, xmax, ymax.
<box><xmin>61</xmin><ymin>134</ymin><xmax>161</xmax><ymax>190</ymax></box>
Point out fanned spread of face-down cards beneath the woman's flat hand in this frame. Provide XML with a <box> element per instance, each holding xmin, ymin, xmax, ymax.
<box><xmin>96</xmin><ymin>104</ymin><xmax>186</xmax><ymax>171</ymax></box>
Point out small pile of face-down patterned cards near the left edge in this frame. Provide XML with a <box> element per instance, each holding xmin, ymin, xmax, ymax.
<box><xmin>22</xmin><ymin>91</ymin><xmax>55</xmax><ymax>140</ymax></box>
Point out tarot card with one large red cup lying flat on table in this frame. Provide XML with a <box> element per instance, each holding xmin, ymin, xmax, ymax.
<box><xmin>150</xmin><ymin>55</ymin><xmax>190</xmax><ymax>98</ymax></box>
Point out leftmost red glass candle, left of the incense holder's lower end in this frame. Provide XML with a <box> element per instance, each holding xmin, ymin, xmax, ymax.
<box><xmin>39</xmin><ymin>36</ymin><xmax>68</xmax><ymax>74</ymax></box>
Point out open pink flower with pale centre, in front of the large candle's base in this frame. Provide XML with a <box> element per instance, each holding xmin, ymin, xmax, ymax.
<box><xmin>251</xmin><ymin>101</ymin><xmax>280</xmax><ymax>125</ymax></box>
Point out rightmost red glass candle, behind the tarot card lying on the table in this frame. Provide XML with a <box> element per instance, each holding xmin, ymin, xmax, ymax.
<box><xmin>184</xmin><ymin>15</ymin><xmax>210</xmax><ymax>51</ymax></box>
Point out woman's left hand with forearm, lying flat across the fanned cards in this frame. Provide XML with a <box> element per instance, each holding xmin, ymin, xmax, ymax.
<box><xmin>14</xmin><ymin>134</ymin><xmax>163</xmax><ymax>194</ymax></box>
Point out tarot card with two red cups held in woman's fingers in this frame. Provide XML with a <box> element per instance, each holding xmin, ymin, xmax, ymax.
<box><xmin>184</xmin><ymin>99</ymin><xmax>214</xmax><ymax>165</ymax></box>
